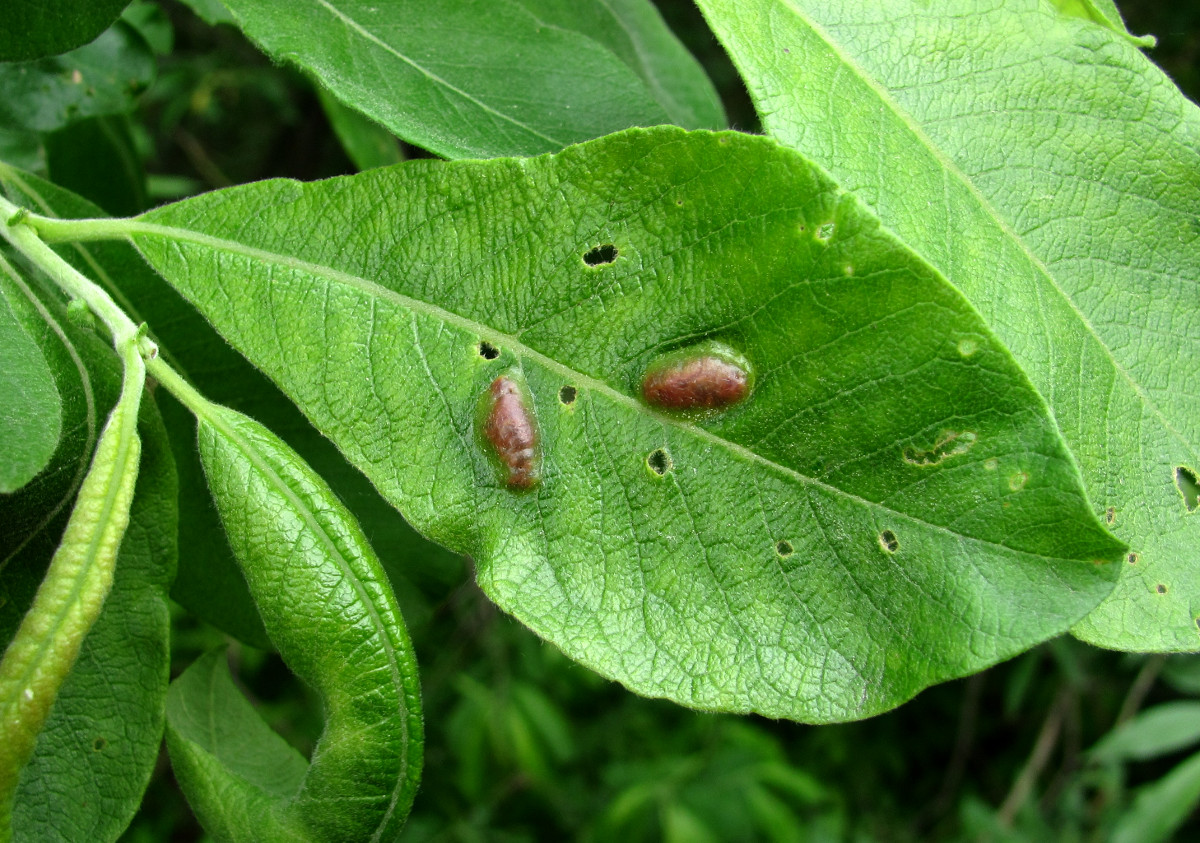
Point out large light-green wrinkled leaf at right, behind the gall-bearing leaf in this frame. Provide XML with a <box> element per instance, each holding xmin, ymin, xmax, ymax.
<box><xmin>700</xmin><ymin>0</ymin><xmax>1200</xmax><ymax>651</ymax></box>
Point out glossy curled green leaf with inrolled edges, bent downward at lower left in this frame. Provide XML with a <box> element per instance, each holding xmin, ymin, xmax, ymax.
<box><xmin>173</xmin><ymin>405</ymin><xmax>422</xmax><ymax>841</ymax></box>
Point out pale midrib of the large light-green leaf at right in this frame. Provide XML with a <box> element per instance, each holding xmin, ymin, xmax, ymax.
<box><xmin>768</xmin><ymin>0</ymin><xmax>1200</xmax><ymax>461</ymax></box>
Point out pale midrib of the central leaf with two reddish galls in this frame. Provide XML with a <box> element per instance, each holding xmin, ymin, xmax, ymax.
<box><xmin>126</xmin><ymin>220</ymin><xmax>1099</xmax><ymax>558</ymax></box>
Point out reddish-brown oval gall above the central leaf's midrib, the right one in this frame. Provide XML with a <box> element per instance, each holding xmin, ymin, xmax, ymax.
<box><xmin>642</xmin><ymin>341</ymin><xmax>754</xmax><ymax>412</ymax></box>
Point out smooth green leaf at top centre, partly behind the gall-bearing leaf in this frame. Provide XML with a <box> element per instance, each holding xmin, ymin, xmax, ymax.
<box><xmin>216</xmin><ymin>0</ymin><xmax>724</xmax><ymax>157</ymax></box>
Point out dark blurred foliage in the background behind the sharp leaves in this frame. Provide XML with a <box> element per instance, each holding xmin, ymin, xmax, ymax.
<box><xmin>0</xmin><ymin>0</ymin><xmax>1200</xmax><ymax>843</ymax></box>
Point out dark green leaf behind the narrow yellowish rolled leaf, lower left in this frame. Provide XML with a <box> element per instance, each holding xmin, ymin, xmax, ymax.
<box><xmin>13</xmin><ymin>386</ymin><xmax>178</xmax><ymax>843</ymax></box>
